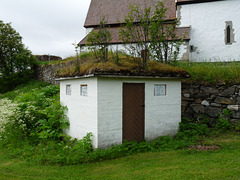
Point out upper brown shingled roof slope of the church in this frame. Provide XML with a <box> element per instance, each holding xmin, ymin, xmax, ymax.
<box><xmin>84</xmin><ymin>0</ymin><xmax>176</xmax><ymax>28</ymax></box>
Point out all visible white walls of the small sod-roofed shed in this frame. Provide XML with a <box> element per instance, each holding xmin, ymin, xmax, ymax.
<box><xmin>60</xmin><ymin>77</ymin><xmax>181</xmax><ymax>148</ymax></box>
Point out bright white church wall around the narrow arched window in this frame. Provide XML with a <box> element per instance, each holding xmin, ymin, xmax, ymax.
<box><xmin>180</xmin><ymin>0</ymin><xmax>240</xmax><ymax>62</ymax></box>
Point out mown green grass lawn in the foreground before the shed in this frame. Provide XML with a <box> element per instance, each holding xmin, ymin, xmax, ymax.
<box><xmin>0</xmin><ymin>133</ymin><xmax>240</xmax><ymax>180</ymax></box>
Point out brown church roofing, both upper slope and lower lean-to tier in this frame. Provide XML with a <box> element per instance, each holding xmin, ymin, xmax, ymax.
<box><xmin>79</xmin><ymin>0</ymin><xmax>190</xmax><ymax>46</ymax></box>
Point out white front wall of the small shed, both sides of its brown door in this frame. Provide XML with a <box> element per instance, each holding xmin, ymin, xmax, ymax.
<box><xmin>98</xmin><ymin>78</ymin><xmax>181</xmax><ymax>147</ymax></box>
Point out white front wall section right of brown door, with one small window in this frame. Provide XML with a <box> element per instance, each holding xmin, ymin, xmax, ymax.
<box><xmin>145</xmin><ymin>80</ymin><xmax>181</xmax><ymax>140</ymax></box>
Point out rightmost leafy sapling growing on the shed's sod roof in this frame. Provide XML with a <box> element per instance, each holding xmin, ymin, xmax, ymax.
<box><xmin>149</xmin><ymin>2</ymin><xmax>182</xmax><ymax>64</ymax></box>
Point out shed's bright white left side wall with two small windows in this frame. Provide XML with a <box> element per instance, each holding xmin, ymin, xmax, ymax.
<box><xmin>60</xmin><ymin>78</ymin><xmax>98</xmax><ymax>147</ymax></box>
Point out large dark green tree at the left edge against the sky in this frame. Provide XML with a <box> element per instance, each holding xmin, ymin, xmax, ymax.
<box><xmin>0</xmin><ymin>20</ymin><xmax>36</xmax><ymax>92</ymax></box>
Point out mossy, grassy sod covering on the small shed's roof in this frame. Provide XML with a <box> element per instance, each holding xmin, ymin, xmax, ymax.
<box><xmin>57</xmin><ymin>58</ymin><xmax>190</xmax><ymax>78</ymax></box>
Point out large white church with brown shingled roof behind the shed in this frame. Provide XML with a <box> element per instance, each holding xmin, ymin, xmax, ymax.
<box><xmin>79</xmin><ymin>0</ymin><xmax>240</xmax><ymax>62</ymax></box>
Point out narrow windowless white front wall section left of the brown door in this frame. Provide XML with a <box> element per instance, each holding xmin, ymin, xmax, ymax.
<box><xmin>98</xmin><ymin>78</ymin><xmax>122</xmax><ymax>147</ymax></box>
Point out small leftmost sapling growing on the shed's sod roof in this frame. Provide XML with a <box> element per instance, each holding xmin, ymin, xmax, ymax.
<box><xmin>87</xmin><ymin>17</ymin><xmax>112</xmax><ymax>61</ymax></box>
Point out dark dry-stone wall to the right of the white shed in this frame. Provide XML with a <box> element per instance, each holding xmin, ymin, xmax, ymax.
<box><xmin>182</xmin><ymin>83</ymin><xmax>240</xmax><ymax>123</ymax></box>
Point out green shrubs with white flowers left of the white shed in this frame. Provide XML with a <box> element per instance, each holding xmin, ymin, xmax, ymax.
<box><xmin>1</xmin><ymin>85</ymin><xmax>69</xmax><ymax>144</ymax></box>
